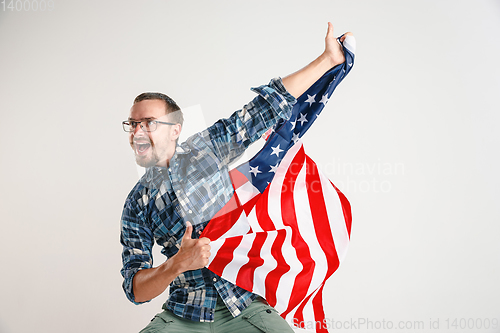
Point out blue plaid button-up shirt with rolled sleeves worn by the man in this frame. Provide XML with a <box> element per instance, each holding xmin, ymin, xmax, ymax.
<box><xmin>120</xmin><ymin>78</ymin><xmax>296</xmax><ymax>321</ymax></box>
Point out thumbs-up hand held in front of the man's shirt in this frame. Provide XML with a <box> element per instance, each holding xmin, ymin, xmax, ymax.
<box><xmin>172</xmin><ymin>222</ymin><xmax>210</xmax><ymax>272</ymax></box>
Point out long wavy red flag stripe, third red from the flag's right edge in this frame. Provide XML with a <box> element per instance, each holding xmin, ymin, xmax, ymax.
<box><xmin>281</xmin><ymin>147</ymin><xmax>316</xmax><ymax>317</ymax></box>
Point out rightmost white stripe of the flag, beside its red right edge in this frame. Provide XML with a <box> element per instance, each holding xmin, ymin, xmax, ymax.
<box><xmin>320</xmin><ymin>174</ymin><xmax>349</xmax><ymax>263</ymax></box>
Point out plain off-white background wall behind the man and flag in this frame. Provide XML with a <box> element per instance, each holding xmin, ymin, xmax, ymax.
<box><xmin>0</xmin><ymin>0</ymin><xmax>500</xmax><ymax>333</ymax></box>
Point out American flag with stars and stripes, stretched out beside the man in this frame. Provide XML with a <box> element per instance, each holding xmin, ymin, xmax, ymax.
<box><xmin>201</xmin><ymin>36</ymin><xmax>355</xmax><ymax>332</ymax></box>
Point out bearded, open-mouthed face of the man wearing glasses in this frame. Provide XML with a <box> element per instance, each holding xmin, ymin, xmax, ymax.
<box><xmin>129</xmin><ymin>99</ymin><xmax>181</xmax><ymax>167</ymax></box>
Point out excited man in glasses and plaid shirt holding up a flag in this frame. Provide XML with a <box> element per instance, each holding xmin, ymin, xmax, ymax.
<box><xmin>121</xmin><ymin>23</ymin><xmax>350</xmax><ymax>333</ymax></box>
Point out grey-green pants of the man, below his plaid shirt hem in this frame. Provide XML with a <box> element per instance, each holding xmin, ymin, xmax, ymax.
<box><xmin>140</xmin><ymin>298</ymin><xmax>293</xmax><ymax>333</ymax></box>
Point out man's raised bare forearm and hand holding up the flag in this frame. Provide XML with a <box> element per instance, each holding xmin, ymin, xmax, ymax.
<box><xmin>283</xmin><ymin>22</ymin><xmax>352</xmax><ymax>98</ymax></box>
